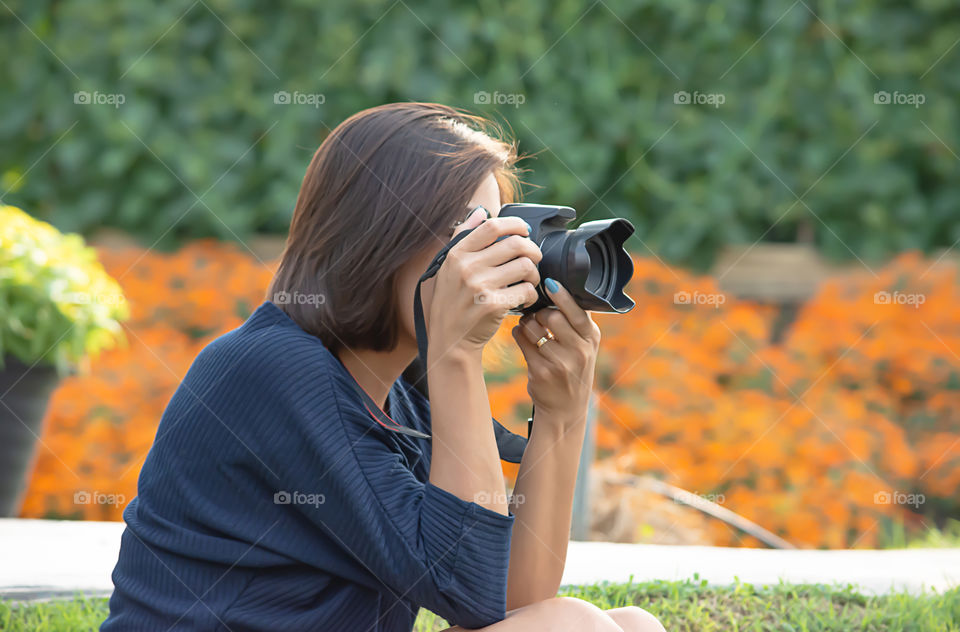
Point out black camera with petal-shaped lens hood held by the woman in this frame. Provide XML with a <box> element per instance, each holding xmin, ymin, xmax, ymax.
<box><xmin>499</xmin><ymin>204</ymin><xmax>635</xmax><ymax>314</ymax></box>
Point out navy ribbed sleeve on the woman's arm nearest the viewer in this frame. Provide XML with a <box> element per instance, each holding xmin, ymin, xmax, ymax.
<box><xmin>255</xmin><ymin>360</ymin><xmax>514</xmax><ymax>628</ymax></box>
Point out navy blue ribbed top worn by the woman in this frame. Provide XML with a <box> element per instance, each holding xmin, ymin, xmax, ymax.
<box><xmin>101</xmin><ymin>301</ymin><xmax>513</xmax><ymax>632</ymax></box>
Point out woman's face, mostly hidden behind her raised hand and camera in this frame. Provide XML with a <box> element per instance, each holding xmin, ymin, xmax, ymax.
<box><xmin>398</xmin><ymin>172</ymin><xmax>500</xmax><ymax>349</ymax></box>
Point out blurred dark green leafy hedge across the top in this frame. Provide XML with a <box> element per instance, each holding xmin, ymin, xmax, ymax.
<box><xmin>0</xmin><ymin>0</ymin><xmax>960</xmax><ymax>265</ymax></box>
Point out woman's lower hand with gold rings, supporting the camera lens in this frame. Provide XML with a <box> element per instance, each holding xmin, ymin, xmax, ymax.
<box><xmin>512</xmin><ymin>279</ymin><xmax>600</xmax><ymax>424</ymax></box>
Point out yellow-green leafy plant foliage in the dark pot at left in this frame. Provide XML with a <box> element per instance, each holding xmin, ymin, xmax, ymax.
<box><xmin>0</xmin><ymin>206</ymin><xmax>128</xmax><ymax>371</ymax></box>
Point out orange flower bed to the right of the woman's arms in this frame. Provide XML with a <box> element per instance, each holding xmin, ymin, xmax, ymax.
<box><xmin>598</xmin><ymin>255</ymin><xmax>960</xmax><ymax>548</ymax></box>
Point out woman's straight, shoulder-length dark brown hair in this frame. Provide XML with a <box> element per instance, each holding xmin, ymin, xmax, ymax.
<box><xmin>267</xmin><ymin>103</ymin><xmax>519</xmax><ymax>351</ymax></box>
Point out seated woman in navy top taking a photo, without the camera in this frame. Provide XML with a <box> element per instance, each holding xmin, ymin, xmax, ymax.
<box><xmin>102</xmin><ymin>103</ymin><xmax>663</xmax><ymax>632</ymax></box>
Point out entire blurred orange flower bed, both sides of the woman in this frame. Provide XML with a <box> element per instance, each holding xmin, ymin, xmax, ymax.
<box><xmin>22</xmin><ymin>241</ymin><xmax>960</xmax><ymax>548</ymax></box>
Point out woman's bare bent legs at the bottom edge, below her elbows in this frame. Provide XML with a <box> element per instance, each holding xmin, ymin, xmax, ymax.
<box><xmin>444</xmin><ymin>597</ymin><xmax>663</xmax><ymax>632</ymax></box>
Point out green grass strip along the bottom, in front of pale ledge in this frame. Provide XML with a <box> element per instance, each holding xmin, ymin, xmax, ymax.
<box><xmin>0</xmin><ymin>580</ymin><xmax>960</xmax><ymax>632</ymax></box>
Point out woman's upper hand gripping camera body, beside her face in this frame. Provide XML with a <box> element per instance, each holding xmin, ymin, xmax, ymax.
<box><xmin>427</xmin><ymin>209</ymin><xmax>543</xmax><ymax>358</ymax></box>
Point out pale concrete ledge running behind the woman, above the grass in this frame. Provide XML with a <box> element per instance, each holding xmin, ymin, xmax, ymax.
<box><xmin>0</xmin><ymin>519</ymin><xmax>960</xmax><ymax>600</ymax></box>
